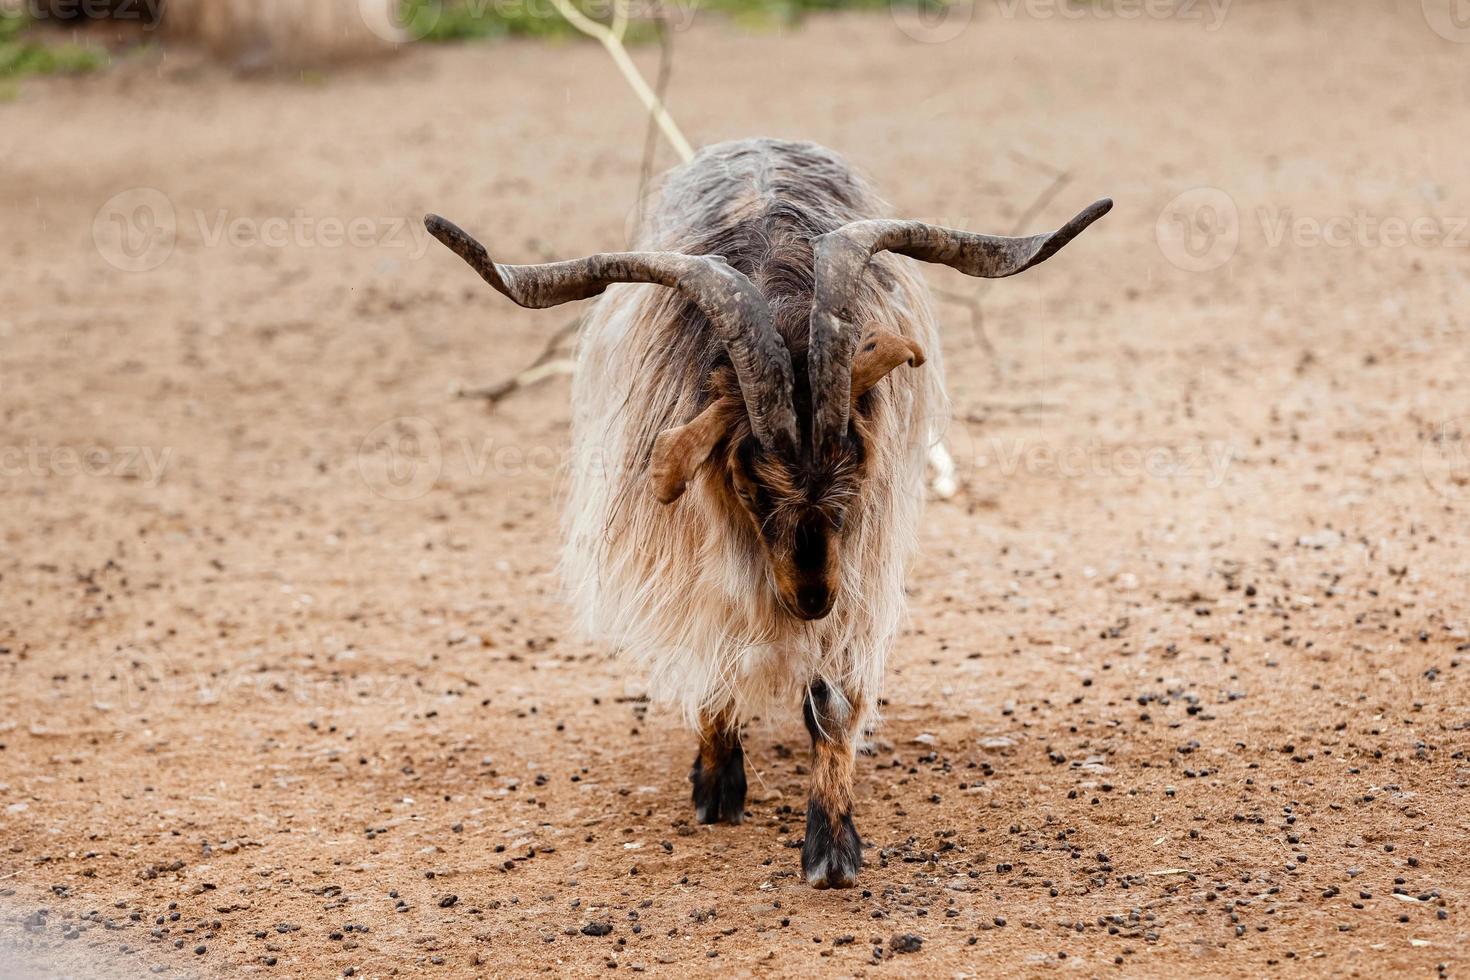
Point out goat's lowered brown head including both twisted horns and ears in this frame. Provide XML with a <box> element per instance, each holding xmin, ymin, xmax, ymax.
<box><xmin>426</xmin><ymin>200</ymin><xmax>1111</xmax><ymax>620</ymax></box>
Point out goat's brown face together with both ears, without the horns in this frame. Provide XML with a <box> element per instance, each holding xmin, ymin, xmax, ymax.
<box><xmin>648</xmin><ymin>326</ymin><xmax>923</xmax><ymax>620</ymax></box>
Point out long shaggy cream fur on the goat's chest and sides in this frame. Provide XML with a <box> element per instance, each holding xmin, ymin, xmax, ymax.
<box><xmin>562</xmin><ymin>215</ymin><xmax>948</xmax><ymax>726</ymax></box>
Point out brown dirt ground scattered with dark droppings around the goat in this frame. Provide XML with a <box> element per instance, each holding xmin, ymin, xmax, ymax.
<box><xmin>0</xmin><ymin>0</ymin><xmax>1470</xmax><ymax>980</ymax></box>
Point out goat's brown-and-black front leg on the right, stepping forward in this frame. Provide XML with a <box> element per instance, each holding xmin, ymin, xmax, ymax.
<box><xmin>801</xmin><ymin>680</ymin><xmax>863</xmax><ymax>887</ymax></box>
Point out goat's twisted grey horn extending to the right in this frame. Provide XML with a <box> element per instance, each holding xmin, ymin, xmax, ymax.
<box><xmin>807</xmin><ymin>198</ymin><xmax>1113</xmax><ymax>445</ymax></box>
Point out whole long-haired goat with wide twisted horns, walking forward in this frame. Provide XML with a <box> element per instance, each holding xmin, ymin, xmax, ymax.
<box><xmin>426</xmin><ymin>140</ymin><xmax>1111</xmax><ymax>887</ymax></box>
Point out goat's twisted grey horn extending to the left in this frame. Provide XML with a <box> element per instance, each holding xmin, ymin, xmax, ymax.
<box><xmin>423</xmin><ymin>215</ymin><xmax>798</xmax><ymax>447</ymax></box>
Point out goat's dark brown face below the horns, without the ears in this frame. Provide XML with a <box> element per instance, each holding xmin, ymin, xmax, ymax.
<box><xmin>726</xmin><ymin>435</ymin><xmax>863</xmax><ymax>620</ymax></box>
